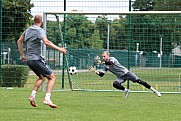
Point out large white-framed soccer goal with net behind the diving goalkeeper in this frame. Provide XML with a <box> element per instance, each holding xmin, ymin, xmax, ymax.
<box><xmin>43</xmin><ymin>11</ymin><xmax>181</xmax><ymax>93</ymax></box>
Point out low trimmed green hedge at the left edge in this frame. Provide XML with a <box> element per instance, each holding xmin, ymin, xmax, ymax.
<box><xmin>0</xmin><ymin>65</ymin><xmax>29</xmax><ymax>87</ymax></box>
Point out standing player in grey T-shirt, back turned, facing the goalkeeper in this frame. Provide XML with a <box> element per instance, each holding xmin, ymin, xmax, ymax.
<box><xmin>17</xmin><ymin>14</ymin><xmax>67</xmax><ymax>108</ymax></box>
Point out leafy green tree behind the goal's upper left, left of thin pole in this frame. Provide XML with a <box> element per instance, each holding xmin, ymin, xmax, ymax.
<box><xmin>63</xmin><ymin>15</ymin><xmax>103</xmax><ymax>49</ymax></box>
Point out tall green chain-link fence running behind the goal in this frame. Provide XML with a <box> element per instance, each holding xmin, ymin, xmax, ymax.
<box><xmin>0</xmin><ymin>0</ymin><xmax>181</xmax><ymax>92</ymax></box>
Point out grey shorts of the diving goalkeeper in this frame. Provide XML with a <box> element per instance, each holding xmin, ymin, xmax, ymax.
<box><xmin>115</xmin><ymin>72</ymin><xmax>139</xmax><ymax>84</ymax></box>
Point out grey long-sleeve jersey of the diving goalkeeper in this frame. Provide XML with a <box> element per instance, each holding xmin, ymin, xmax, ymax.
<box><xmin>101</xmin><ymin>57</ymin><xmax>129</xmax><ymax>77</ymax></box>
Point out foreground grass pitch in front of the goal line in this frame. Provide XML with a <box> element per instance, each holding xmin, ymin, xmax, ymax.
<box><xmin>0</xmin><ymin>88</ymin><xmax>181</xmax><ymax>121</ymax></box>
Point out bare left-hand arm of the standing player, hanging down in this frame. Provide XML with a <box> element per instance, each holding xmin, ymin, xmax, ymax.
<box><xmin>17</xmin><ymin>35</ymin><xmax>26</xmax><ymax>62</ymax></box>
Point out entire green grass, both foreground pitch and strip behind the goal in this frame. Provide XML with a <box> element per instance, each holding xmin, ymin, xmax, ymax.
<box><xmin>0</xmin><ymin>68</ymin><xmax>181</xmax><ymax>121</ymax></box>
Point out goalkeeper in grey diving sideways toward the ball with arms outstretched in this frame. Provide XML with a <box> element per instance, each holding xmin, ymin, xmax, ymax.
<box><xmin>95</xmin><ymin>51</ymin><xmax>161</xmax><ymax>98</ymax></box>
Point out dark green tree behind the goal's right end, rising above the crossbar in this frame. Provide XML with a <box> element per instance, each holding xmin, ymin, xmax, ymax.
<box><xmin>127</xmin><ymin>0</ymin><xmax>181</xmax><ymax>53</ymax></box>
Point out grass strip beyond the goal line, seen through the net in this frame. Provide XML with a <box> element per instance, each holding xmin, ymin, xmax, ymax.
<box><xmin>25</xmin><ymin>68</ymin><xmax>181</xmax><ymax>92</ymax></box>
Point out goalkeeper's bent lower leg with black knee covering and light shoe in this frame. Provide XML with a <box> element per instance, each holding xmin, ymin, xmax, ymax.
<box><xmin>113</xmin><ymin>81</ymin><xmax>130</xmax><ymax>98</ymax></box>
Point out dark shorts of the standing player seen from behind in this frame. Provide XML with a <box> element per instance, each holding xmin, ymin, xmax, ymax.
<box><xmin>27</xmin><ymin>60</ymin><xmax>52</xmax><ymax>77</ymax></box>
